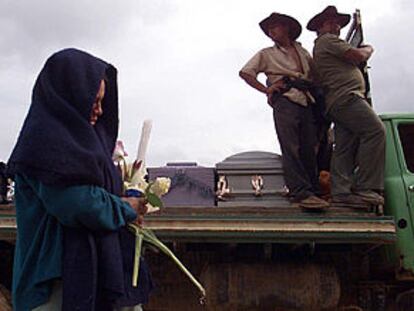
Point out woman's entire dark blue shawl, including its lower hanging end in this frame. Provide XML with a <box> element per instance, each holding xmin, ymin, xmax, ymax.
<box><xmin>8</xmin><ymin>49</ymin><xmax>151</xmax><ymax>311</ymax></box>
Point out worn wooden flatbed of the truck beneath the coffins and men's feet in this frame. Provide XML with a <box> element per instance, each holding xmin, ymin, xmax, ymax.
<box><xmin>0</xmin><ymin>205</ymin><xmax>396</xmax><ymax>244</ymax></box>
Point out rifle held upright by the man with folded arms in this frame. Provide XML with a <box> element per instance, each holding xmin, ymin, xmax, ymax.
<box><xmin>345</xmin><ymin>9</ymin><xmax>372</xmax><ymax>106</ymax></box>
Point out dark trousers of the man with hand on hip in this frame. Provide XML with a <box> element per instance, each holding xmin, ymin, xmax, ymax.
<box><xmin>272</xmin><ymin>96</ymin><xmax>319</xmax><ymax>201</ymax></box>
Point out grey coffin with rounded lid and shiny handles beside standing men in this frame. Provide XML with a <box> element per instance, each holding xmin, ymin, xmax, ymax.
<box><xmin>216</xmin><ymin>151</ymin><xmax>290</xmax><ymax>207</ymax></box>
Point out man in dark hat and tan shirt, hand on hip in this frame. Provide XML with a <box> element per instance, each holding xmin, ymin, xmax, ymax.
<box><xmin>239</xmin><ymin>13</ymin><xmax>329</xmax><ymax>209</ymax></box>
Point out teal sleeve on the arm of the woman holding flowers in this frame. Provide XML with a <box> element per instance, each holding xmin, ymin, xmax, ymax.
<box><xmin>24</xmin><ymin>180</ymin><xmax>137</xmax><ymax>230</ymax></box>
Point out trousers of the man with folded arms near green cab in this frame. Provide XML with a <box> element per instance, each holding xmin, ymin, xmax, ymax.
<box><xmin>328</xmin><ymin>95</ymin><xmax>385</xmax><ymax>195</ymax></box>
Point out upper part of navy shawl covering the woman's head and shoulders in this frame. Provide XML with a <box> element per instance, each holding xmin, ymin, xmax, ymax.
<box><xmin>8</xmin><ymin>49</ymin><xmax>118</xmax><ymax>191</ymax></box>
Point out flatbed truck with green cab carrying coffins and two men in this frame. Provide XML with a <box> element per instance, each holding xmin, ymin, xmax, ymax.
<box><xmin>0</xmin><ymin>114</ymin><xmax>414</xmax><ymax>311</ymax></box>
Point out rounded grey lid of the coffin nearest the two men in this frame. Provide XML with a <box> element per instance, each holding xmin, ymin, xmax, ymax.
<box><xmin>216</xmin><ymin>151</ymin><xmax>282</xmax><ymax>171</ymax></box>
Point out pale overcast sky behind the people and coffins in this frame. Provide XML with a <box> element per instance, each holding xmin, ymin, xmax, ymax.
<box><xmin>0</xmin><ymin>0</ymin><xmax>414</xmax><ymax>166</ymax></box>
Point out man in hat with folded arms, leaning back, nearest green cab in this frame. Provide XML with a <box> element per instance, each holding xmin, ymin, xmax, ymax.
<box><xmin>307</xmin><ymin>6</ymin><xmax>385</xmax><ymax>204</ymax></box>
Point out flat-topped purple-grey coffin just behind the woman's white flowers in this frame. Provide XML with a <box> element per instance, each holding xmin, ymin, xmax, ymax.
<box><xmin>148</xmin><ymin>162</ymin><xmax>216</xmax><ymax>207</ymax></box>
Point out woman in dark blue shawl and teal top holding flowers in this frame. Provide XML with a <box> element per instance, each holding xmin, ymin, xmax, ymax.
<box><xmin>8</xmin><ymin>49</ymin><xmax>152</xmax><ymax>311</ymax></box>
